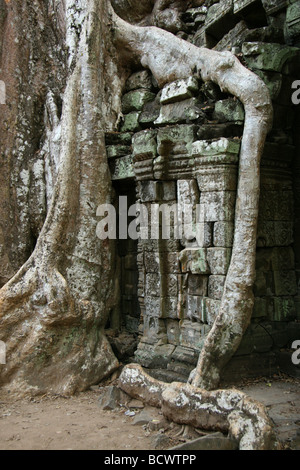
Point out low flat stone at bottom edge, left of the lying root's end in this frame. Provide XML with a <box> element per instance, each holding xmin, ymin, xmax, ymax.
<box><xmin>169</xmin><ymin>432</ymin><xmax>238</xmax><ymax>451</ymax></box>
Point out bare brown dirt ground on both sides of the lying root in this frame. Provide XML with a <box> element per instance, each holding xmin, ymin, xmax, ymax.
<box><xmin>0</xmin><ymin>370</ymin><xmax>300</xmax><ymax>450</ymax></box>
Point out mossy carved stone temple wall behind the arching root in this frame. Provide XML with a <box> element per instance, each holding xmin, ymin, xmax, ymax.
<box><xmin>106</xmin><ymin>0</ymin><xmax>300</xmax><ymax>379</ymax></box>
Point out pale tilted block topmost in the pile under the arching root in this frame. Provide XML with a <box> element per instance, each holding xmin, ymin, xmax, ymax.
<box><xmin>160</xmin><ymin>77</ymin><xmax>199</xmax><ymax>104</ymax></box>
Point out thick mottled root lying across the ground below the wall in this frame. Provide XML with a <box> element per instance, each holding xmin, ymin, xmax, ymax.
<box><xmin>119</xmin><ymin>364</ymin><xmax>278</xmax><ymax>450</ymax></box>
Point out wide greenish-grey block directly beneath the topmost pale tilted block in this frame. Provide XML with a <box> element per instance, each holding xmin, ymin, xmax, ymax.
<box><xmin>154</xmin><ymin>98</ymin><xmax>206</xmax><ymax>126</ymax></box>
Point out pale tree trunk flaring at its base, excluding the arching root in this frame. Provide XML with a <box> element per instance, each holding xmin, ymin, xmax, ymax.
<box><xmin>0</xmin><ymin>1</ymin><xmax>122</xmax><ymax>394</ymax></box>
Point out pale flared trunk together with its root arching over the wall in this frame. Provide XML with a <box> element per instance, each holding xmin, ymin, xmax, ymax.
<box><xmin>0</xmin><ymin>0</ymin><xmax>271</xmax><ymax>394</ymax></box>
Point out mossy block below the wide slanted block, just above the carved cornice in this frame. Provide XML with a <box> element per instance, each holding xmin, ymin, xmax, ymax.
<box><xmin>157</xmin><ymin>124</ymin><xmax>198</xmax><ymax>156</ymax></box>
